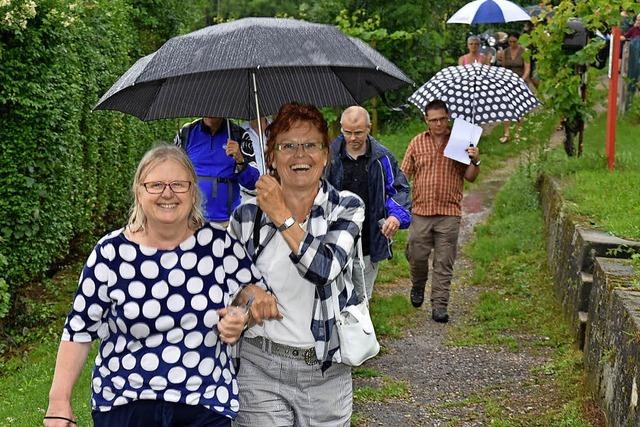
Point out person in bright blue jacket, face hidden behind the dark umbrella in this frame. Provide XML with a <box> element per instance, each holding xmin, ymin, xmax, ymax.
<box><xmin>173</xmin><ymin>117</ymin><xmax>260</xmax><ymax>226</ymax></box>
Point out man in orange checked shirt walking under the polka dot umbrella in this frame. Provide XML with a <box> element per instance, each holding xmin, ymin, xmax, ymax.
<box><xmin>401</xmin><ymin>99</ymin><xmax>480</xmax><ymax>323</ymax></box>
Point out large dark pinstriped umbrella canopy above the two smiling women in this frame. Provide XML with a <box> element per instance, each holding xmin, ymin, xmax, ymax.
<box><xmin>94</xmin><ymin>18</ymin><xmax>412</xmax><ymax>120</ymax></box>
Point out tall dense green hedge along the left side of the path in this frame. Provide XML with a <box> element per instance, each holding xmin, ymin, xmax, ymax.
<box><xmin>0</xmin><ymin>0</ymin><xmax>208</xmax><ymax>324</ymax></box>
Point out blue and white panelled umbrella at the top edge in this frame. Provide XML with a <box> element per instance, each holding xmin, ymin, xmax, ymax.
<box><xmin>447</xmin><ymin>0</ymin><xmax>531</xmax><ymax>24</ymax></box>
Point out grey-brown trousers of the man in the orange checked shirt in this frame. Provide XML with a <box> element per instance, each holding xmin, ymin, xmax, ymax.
<box><xmin>406</xmin><ymin>215</ymin><xmax>460</xmax><ymax>308</ymax></box>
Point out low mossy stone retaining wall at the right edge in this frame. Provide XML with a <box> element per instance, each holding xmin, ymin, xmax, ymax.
<box><xmin>539</xmin><ymin>175</ymin><xmax>640</xmax><ymax>426</ymax></box>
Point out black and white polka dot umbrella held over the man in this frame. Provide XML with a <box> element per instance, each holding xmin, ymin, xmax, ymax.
<box><xmin>409</xmin><ymin>63</ymin><xmax>540</xmax><ymax>124</ymax></box>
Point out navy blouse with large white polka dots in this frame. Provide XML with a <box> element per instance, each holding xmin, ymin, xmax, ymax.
<box><xmin>63</xmin><ymin>225</ymin><xmax>260</xmax><ymax>416</ymax></box>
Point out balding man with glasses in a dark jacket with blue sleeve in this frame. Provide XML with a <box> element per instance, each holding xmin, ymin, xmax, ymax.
<box><xmin>325</xmin><ymin>106</ymin><xmax>411</xmax><ymax>301</ymax></box>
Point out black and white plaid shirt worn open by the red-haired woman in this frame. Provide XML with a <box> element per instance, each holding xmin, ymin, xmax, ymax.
<box><xmin>229</xmin><ymin>180</ymin><xmax>364</xmax><ymax>369</ymax></box>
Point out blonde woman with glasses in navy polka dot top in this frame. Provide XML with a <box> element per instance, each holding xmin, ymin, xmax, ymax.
<box><xmin>44</xmin><ymin>145</ymin><xmax>268</xmax><ymax>427</ymax></box>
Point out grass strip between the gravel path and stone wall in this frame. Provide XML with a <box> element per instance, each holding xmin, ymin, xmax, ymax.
<box><xmin>449</xmin><ymin>167</ymin><xmax>590</xmax><ymax>427</ymax></box>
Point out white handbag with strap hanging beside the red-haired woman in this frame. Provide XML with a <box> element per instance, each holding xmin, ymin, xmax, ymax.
<box><xmin>332</xmin><ymin>247</ymin><xmax>380</xmax><ymax>366</ymax></box>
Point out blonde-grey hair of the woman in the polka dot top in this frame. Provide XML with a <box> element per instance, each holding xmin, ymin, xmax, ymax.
<box><xmin>127</xmin><ymin>144</ymin><xmax>205</xmax><ymax>233</ymax></box>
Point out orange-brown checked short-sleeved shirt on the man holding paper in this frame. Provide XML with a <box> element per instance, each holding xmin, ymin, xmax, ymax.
<box><xmin>401</xmin><ymin>131</ymin><xmax>467</xmax><ymax>216</ymax></box>
